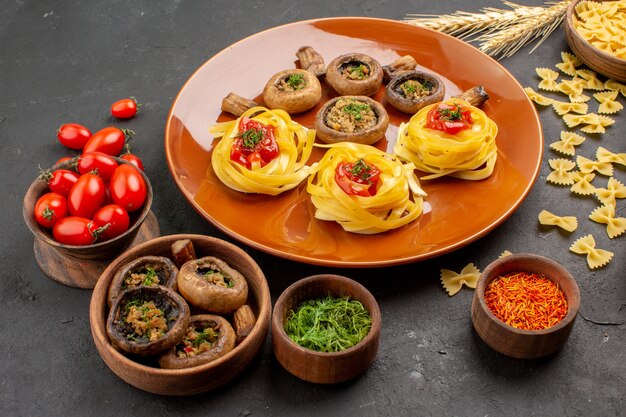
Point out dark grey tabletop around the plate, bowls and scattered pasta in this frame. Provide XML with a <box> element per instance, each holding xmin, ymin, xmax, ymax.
<box><xmin>0</xmin><ymin>0</ymin><xmax>626</xmax><ymax>416</ymax></box>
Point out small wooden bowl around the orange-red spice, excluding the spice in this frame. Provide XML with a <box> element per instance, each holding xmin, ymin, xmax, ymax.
<box><xmin>472</xmin><ymin>254</ymin><xmax>580</xmax><ymax>359</ymax></box>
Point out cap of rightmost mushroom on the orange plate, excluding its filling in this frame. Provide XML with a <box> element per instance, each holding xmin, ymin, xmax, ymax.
<box><xmin>386</xmin><ymin>71</ymin><xmax>446</xmax><ymax>114</ymax></box>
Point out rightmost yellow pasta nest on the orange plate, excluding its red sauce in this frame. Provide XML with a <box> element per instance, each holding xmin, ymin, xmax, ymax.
<box><xmin>393</xmin><ymin>99</ymin><xmax>498</xmax><ymax>180</ymax></box>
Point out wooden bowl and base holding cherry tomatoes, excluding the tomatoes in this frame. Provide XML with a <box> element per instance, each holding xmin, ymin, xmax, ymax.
<box><xmin>22</xmin><ymin>158</ymin><xmax>159</xmax><ymax>288</ymax></box>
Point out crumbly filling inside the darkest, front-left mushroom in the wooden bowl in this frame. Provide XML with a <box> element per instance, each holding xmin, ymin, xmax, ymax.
<box><xmin>124</xmin><ymin>300</ymin><xmax>168</xmax><ymax>342</ymax></box>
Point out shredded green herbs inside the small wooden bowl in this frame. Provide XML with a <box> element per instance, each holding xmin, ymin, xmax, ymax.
<box><xmin>285</xmin><ymin>296</ymin><xmax>372</xmax><ymax>352</ymax></box>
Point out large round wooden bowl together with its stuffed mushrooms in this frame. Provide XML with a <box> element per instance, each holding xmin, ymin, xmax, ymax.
<box><xmin>89</xmin><ymin>235</ymin><xmax>271</xmax><ymax>396</ymax></box>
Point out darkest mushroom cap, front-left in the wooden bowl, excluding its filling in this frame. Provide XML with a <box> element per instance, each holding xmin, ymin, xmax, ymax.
<box><xmin>106</xmin><ymin>285</ymin><xmax>189</xmax><ymax>356</ymax></box>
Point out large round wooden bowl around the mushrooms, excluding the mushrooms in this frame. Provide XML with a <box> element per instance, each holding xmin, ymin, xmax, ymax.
<box><xmin>89</xmin><ymin>235</ymin><xmax>271</xmax><ymax>396</ymax></box>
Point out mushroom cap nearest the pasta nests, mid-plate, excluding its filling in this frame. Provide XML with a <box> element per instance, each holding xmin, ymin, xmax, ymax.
<box><xmin>315</xmin><ymin>96</ymin><xmax>389</xmax><ymax>145</ymax></box>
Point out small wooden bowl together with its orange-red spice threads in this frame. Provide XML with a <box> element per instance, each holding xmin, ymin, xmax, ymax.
<box><xmin>472</xmin><ymin>253</ymin><xmax>580</xmax><ymax>359</ymax></box>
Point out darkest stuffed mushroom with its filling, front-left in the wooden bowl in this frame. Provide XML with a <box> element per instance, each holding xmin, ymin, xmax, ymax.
<box><xmin>107</xmin><ymin>285</ymin><xmax>189</xmax><ymax>356</ymax></box>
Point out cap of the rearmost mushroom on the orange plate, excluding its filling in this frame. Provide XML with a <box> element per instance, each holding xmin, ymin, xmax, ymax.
<box><xmin>326</xmin><ymin>53</ymin><xmax>383</xmax><ymax>96</ymax></box>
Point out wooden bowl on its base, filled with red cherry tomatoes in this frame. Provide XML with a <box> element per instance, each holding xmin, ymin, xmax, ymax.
<box><xmin>23</xmin><ymin>152</ymin><xmax>159</xmax><ymax>288</ymax></box>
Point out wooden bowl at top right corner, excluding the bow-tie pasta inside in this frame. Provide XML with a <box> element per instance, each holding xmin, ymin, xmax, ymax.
<box><xmin>565</xmin><ymin>0</ymin><xmax>626</xmax><ymax>81</ymax></box>
